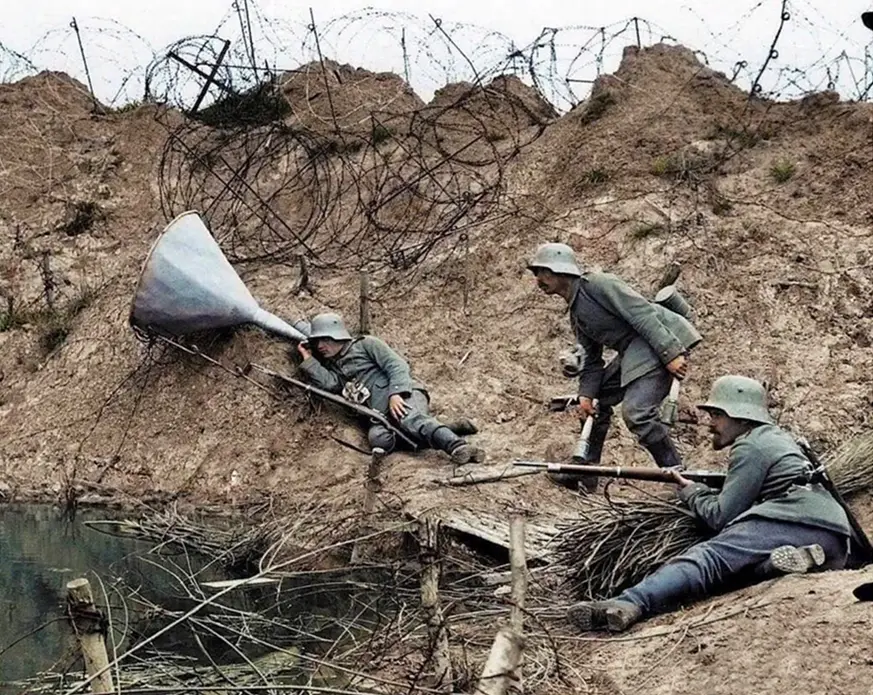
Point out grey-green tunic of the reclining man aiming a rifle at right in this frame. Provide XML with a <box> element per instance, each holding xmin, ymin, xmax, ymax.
<box><xmin>679</xmin><ymin>425</ymin><xmax>850</xmax><ymax>536</ymax></box>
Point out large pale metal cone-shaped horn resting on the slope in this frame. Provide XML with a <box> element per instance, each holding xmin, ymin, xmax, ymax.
<box><xmin>128</xmin><ymin>211</ymin><xmax>309</xmax><ymax>341</ymax></box>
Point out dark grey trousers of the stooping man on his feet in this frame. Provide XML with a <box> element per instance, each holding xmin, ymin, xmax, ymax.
<box><xmin>588</xmin><ymin>358</ymin><xmax>681</xmax><ymax>466</ymax></box>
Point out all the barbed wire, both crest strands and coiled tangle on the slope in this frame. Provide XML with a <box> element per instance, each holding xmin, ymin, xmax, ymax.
<box><xmin>0</xmin><ymin>0</ymin><xmax>873</xmax><ymax>290</ymax></box>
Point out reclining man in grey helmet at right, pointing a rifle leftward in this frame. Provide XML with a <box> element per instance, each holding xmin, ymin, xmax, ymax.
<box><xmin>570</xmin><ymin>376</ymin><xmax>851</xmax><ymax>632</ymax></box>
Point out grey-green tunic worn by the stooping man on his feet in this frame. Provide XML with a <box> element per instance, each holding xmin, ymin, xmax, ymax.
<box><xmin>570</xmin><ymin>273</ymin><xmax>702</xmax><ymax>397</ymax></box>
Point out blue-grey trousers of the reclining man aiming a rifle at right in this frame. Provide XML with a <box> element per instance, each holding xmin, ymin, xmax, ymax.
<box><xmin>618</xmin><ymin>517</ymin><xmax>849</xmax><ymax>615</ymax></box>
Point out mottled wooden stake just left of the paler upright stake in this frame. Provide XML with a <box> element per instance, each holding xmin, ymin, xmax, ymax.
<box><xmin>419</xmin><ymin>517</ymin><xmax>454</xmax><ymax>693</ymax></box>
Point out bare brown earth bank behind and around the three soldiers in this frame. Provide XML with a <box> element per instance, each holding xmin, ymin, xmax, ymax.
<box><xmin>0</xmin><ymin>45</ymin><xmax>873</xmax><ymax>693</ymax></box>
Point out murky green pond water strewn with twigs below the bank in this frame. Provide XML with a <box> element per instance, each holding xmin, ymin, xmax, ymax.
<box><xmin>0</xmin><ymin>505</ymin><xmax>397</xmax><ymax>694</ymax></box>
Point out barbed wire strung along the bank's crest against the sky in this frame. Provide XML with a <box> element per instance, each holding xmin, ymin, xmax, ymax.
<box><xmin>0</xmin><ymin>0</ymin><xmax>873</xmax><ymax>112</ymax></box>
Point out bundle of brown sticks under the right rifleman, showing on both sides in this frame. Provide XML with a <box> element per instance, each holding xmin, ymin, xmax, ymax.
<box><xmin>553</xmin><ymin>435</ymin><xmax>873</xmax><ymax>599</ymax></box>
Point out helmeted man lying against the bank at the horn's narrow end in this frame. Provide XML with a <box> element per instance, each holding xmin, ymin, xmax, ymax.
<box><xmin>297</xmin><ymin>313</ymin><xmax>485</xmax><ymax>465</ymax></box>
